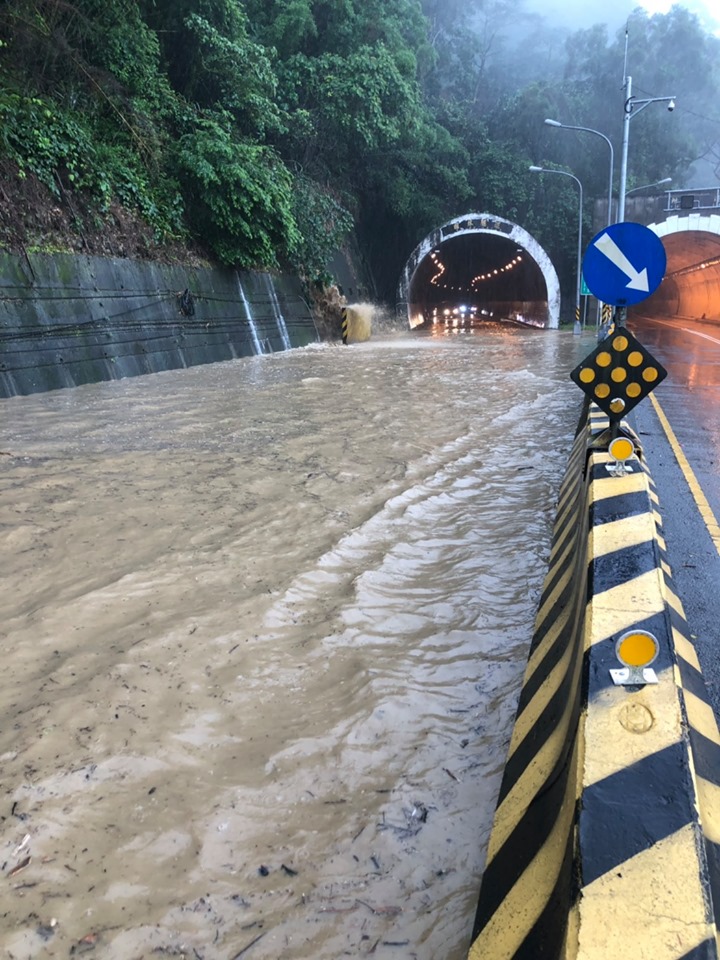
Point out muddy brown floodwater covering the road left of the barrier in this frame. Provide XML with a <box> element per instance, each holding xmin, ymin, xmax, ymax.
<box><xmin>0</xmin><ymin>328</ymin><xmax>592</xmax><ymax>960</ymax></box>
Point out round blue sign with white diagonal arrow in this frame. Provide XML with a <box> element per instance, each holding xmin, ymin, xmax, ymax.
<box><xmin>582</xmin><ymin>220</ymin><xmax>667</xmax><ymax>307</ymax></box>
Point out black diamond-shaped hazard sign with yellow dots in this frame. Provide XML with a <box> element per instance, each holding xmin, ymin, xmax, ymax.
<box><xmin>570</xmin><ymin>327</ymin><xmax>667</xmax><ymax>420</ymax></box>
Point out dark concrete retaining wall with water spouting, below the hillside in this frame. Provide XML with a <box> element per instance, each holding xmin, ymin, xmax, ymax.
<box><xmin>0</xmin><ymin>254</ymin><xmax>318</xmax><ymax>397</ymax></box>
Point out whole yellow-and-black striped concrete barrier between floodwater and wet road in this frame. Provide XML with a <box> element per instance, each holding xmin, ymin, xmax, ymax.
<box><xmin>469</xmin><ymin>407</ymin><xmax>720</xmax><ymax>960</ymax></box>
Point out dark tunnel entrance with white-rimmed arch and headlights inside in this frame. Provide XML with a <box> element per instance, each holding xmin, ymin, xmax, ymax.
<box><xmin>398</xmin><ymin>213</ymin><xmax>560</xmax><ymax>328</ymax></box>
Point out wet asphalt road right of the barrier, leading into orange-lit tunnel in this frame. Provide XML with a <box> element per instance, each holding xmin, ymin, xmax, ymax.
<box><xmin>628</xmin><ymin>317</ymin><xmax>720</xmax><ymax>718</ymax></box>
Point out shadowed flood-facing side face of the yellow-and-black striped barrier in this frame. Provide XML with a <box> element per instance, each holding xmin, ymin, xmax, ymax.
<box><xmin>469</xmin><ymin>412</ymin><xmax>589</xmax><ymax>960</ymax></box>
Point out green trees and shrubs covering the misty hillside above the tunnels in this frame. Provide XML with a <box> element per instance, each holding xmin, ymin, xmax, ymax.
<box><xmin>0</xmin><ymin>0</ymin><xmax>720</xmax><ymax>297</ymax></box>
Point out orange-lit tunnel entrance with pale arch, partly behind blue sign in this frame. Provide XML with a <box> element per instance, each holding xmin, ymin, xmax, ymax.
<box><xmin>637</xmin><ymin>213</ymin><xmax>720</xmax><ymax>320</ymax></box>
